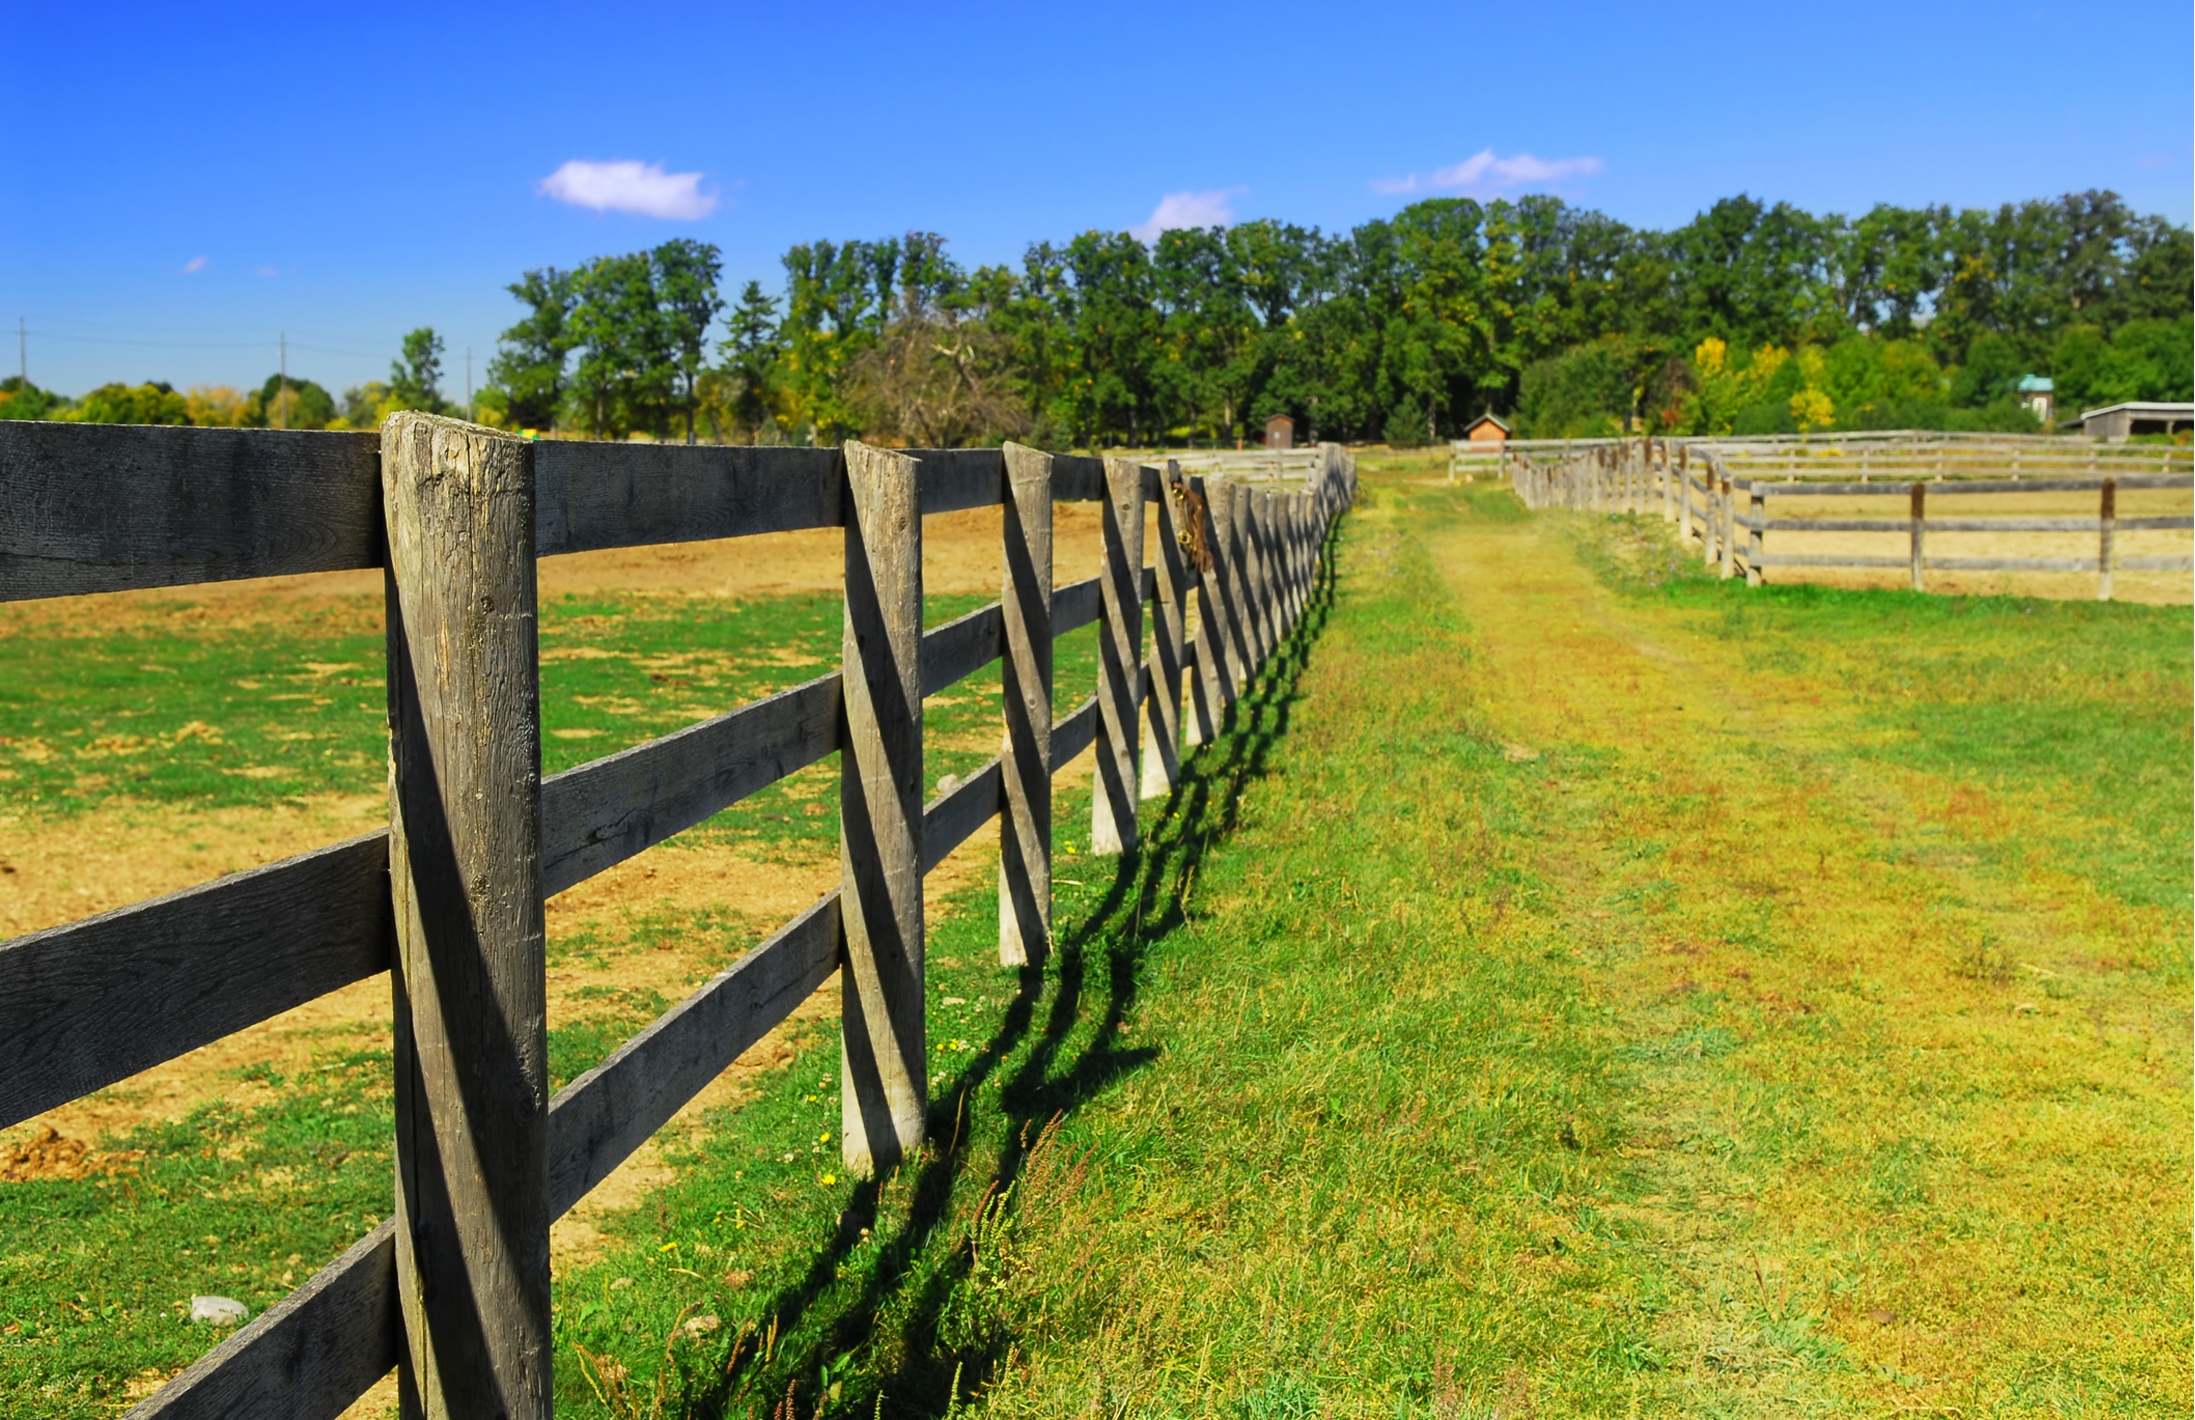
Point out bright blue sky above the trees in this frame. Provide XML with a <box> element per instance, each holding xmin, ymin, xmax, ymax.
<box><xmin>0</xmin><ymin>0</ymin><xmax>2195</xmax><ymax>393</ymax></box>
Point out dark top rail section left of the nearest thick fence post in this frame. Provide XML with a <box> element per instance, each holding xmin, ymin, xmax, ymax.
<box><xmin>0</xmin><ymin>419</ymin><xmax>382</xmax><ymax>601</ymax></box>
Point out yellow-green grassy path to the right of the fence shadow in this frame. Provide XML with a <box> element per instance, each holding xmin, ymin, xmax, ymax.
<box><xmin>970</xmin><ymin>478</ymin><xmax>2188</xmax><ymax>1416</ymax></box>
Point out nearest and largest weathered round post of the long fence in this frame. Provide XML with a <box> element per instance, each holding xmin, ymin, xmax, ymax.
<box><xmin>382</xmin><ymin>413</ymin><xmax>553</xmax><ymax>1420</ymax></box>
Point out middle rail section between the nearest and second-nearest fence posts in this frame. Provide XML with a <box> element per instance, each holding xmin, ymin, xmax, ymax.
<box><xmin>542</xmin><ymin>672</ymin><xmax>838</xmax><ymax>895</ymax></box>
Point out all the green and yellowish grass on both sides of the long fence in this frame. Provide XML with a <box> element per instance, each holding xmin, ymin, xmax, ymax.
<box><xmin>0</xmin><ymin>461</ymin><xmax>2195</xmax><ymax>1420</ymax></box>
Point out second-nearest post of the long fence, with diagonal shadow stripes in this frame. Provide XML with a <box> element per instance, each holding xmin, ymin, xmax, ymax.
<box><xmin>838</xmin><ymin>441</ymin><xmax>928</xmax><ymax>1174</ymax></box>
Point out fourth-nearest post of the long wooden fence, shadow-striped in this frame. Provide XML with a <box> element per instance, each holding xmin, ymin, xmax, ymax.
<box><xmin>1091</xmin><ymin>459</ymin><xmax>1144</xmax><ymax>854</ymax></box>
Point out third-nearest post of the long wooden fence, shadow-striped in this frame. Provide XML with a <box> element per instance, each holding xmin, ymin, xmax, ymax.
<box><xmin>999</xmin><ymin>443</ymin><xmax>1051</xmax><ymax>966</ymax></box>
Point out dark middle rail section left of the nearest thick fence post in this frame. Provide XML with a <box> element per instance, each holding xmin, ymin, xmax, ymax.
<box><xmin>0</xmin><ymin>832</ymin><xmax>393</xmax><ymax>1126</ymax></box>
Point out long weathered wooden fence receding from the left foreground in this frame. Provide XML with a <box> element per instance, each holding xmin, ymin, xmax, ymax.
<box><xmin>0</xmin><ymin>415</ymin><xmax>1354</xmax><ymax>1420</ymax></box>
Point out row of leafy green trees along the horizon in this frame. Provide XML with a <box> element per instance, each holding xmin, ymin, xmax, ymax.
<box><xmin>0</xmin><ymin>191</ymin><xmax>2195</xmax><ymax>448</ymax></box>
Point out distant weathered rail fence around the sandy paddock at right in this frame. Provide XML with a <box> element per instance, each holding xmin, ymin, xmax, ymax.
<box><xmin>1515</xmin><ymin>427</ymin><xmax>2195</xmax><ymax>601</ymax></box>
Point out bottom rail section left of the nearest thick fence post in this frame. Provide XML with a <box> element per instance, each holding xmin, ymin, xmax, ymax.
<box><xmin>127</xmin><ymin>1218</ymin><xmax>404</xmax><ymax>1420</ymax></box>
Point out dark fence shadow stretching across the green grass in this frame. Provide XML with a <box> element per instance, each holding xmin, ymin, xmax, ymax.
<box><xmin>687</xmin><ymin>520</ymin><xmax>1341</xmax><ymax>1418</ymax></box>
